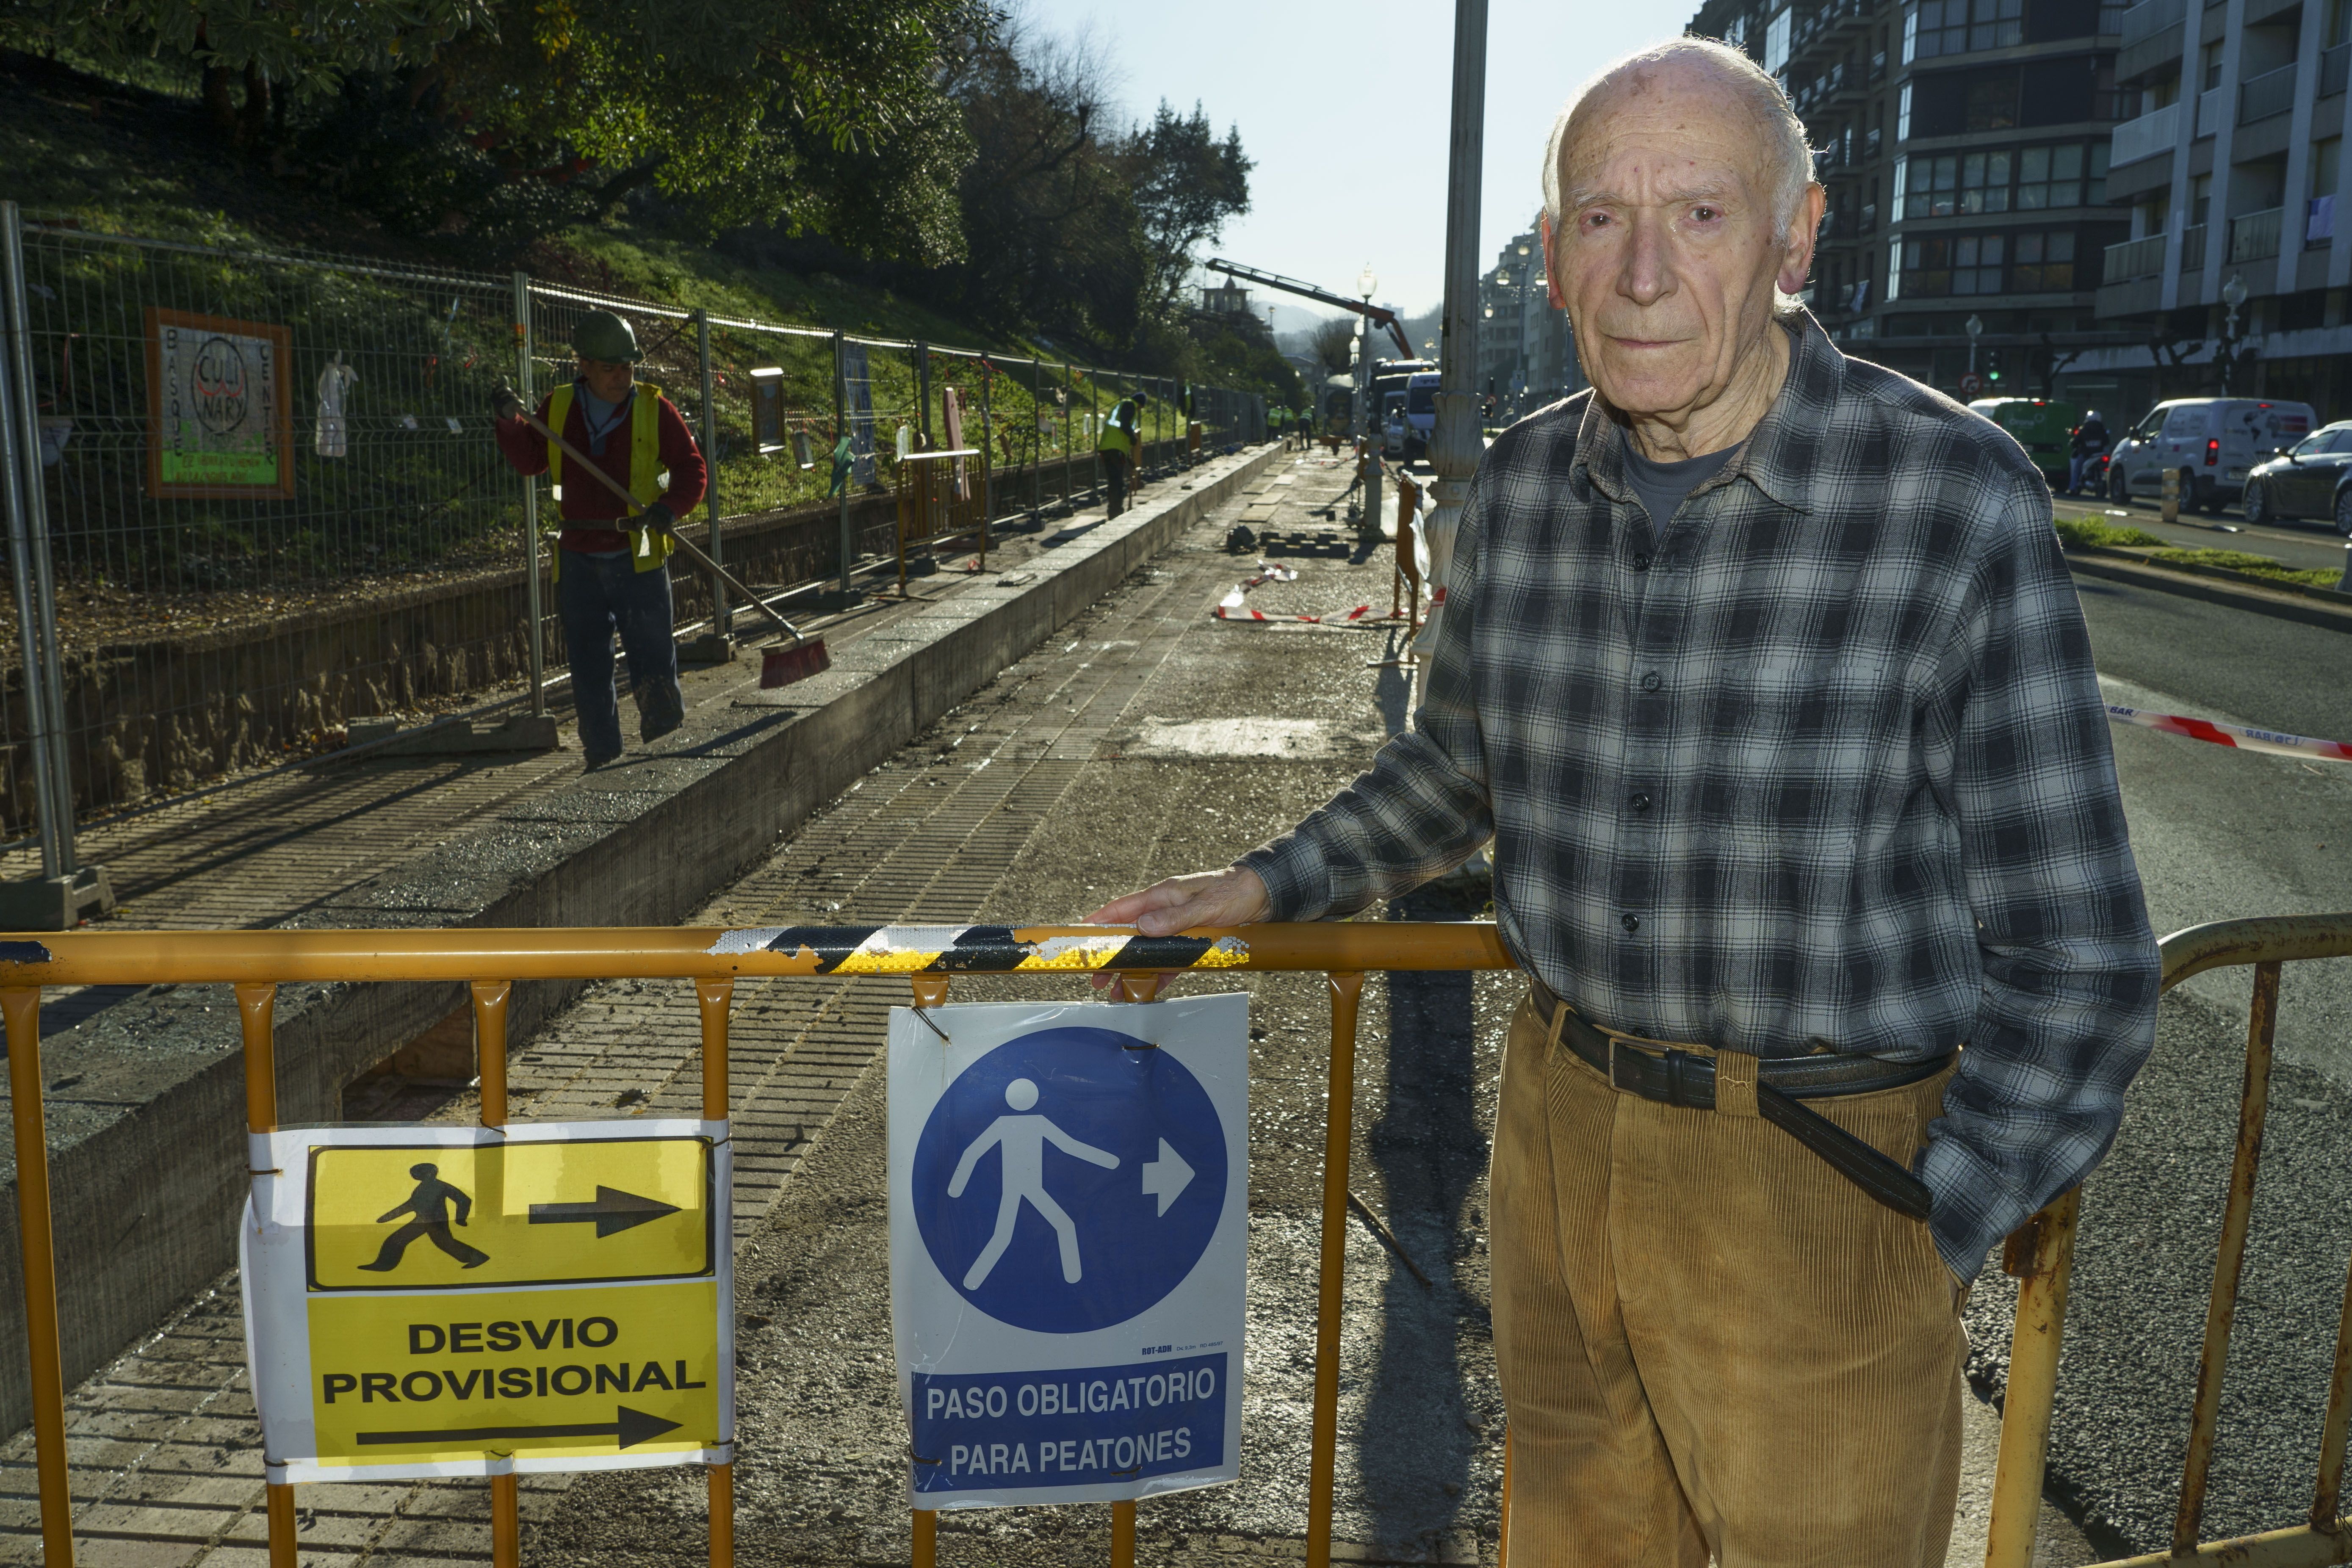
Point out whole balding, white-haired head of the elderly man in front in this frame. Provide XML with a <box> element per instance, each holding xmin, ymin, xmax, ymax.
<box><xmin>1543</xmin><ymin>38</ymin><xmax>1823</xmax><ymax>459</ymax></box>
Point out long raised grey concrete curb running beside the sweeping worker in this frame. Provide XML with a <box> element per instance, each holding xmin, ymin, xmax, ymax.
<box><xmin>0</xmin><ymin>447</ymin><xmax>1279</xmax><ymax>1429</ymax></box>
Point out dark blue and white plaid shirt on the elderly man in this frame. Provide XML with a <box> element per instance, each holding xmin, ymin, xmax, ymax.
<box><xmin>1242</xmin><ymin>315</ymin><xmax>2159</xmax><ymax>1279</ymax></box>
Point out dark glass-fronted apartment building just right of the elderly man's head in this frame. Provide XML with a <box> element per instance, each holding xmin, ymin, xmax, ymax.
<box><xmin>1691</xmin><ymin>0</ymin><xmax>2133</xmax><ymax>400</ymax></box>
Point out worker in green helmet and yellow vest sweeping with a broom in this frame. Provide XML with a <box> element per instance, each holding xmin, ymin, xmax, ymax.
<box><xmin>492</xmin><ymin>310</ymin><xmax>708</xmax><ymax>769</ymax></box>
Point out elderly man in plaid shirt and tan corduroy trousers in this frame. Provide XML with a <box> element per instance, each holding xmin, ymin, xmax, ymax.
<box><xmin>1099</xmin><ymin>38</ymin><xmax>2157</xmax><ymax>1568</ymax></box>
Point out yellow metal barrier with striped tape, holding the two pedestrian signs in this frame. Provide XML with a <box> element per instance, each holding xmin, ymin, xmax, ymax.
<box><xmin>0</xmin><ymin>926</ymin><xmax>1512</xmax><ymax>1568</ymax></box>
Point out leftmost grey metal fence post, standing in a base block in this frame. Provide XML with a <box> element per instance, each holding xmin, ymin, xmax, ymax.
<box><xmin>0</xmin><ymin>202</ymin><xmax>108</xmax><ymax>931</ymax></box>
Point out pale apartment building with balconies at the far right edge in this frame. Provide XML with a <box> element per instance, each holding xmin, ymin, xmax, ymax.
<box><xmin>2079</xmin><ymin>0</ymin><xmax>2352</xmax><ymax>418</ymax></box>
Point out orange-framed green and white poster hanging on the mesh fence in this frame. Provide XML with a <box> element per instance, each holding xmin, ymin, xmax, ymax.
<box><xmin>146</xmin><ymin>306</ymin><xmax>294</xmax><ymax>501</ymax></box>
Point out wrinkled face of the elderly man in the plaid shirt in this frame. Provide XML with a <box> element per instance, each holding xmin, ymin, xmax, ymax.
<box><xmin>1552</xmin><ymin>61</ymin><xmax>1821</xmax><ymax>416</ymax></box>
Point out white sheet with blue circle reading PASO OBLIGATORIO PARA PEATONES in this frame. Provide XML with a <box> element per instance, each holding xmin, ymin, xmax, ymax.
<box><xmin>889</xmin><ymin>997</ymin><xmax>1249</xmax><ymax>1509</ymax></box>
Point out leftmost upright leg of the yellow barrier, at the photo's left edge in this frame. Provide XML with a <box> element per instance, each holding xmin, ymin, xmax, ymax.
<box><xmin>0</xmin><ymin>985</ymin><xmax>73</xmax><ymax>1568</ymax></box>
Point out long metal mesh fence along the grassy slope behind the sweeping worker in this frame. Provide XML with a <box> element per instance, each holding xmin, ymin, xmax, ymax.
<box><xmin>0</xmin><ymin>202</ymin><xmax>1263</xmax><ymax>874</ymax></box>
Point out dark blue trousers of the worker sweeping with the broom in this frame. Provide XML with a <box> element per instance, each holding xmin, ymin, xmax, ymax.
<box><xmin>560</xmin><ymin>550</ymin><xmax>687</xmax><ymax>766</ymax></box>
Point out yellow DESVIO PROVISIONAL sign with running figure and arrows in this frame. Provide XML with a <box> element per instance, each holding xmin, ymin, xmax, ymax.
<box><xmin>242</xmin><ymin>1119</ymin><xmax>734</xmax><ymax>1481</ymax></box>
